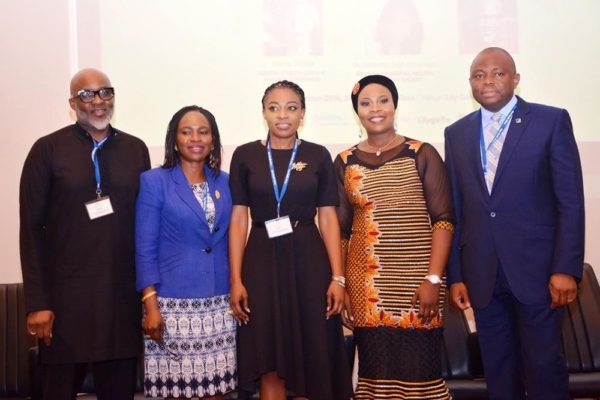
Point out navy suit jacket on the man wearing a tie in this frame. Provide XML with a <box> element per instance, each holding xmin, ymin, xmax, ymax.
<box><xmin>445</xmin><ymin>98</ymin><xmax>585</xmax><ymax>307</ymax></box>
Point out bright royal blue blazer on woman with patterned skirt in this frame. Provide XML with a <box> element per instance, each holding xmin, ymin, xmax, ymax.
<box><xmin>135</xmin><ymin>164</ymin><xmax>231</xmax><ymax>298</ymax></box>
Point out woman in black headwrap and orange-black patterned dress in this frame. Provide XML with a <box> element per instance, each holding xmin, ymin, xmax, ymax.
<box><xmin>335</xmin><ymin>75</ymin><xmax>454</xmax><ymax>399</ymax></box>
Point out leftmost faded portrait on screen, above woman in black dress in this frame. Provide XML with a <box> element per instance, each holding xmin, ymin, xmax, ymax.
<box><xmin>263</xmin><ymin>0</ymin><xmax>323</xmax><ymax>56</ymax></box>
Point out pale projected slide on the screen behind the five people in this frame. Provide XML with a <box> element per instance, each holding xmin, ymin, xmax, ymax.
<box><xmin>86</xmin><ymin>0</ymin><xmax>600</xmax><ymax>145</ymax></box>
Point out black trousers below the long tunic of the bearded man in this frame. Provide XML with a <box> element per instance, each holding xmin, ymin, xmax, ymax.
<box><xmin>42</xmin><ymin>358</ymin><xmax>137</xmax><ymax>400</ymax></box>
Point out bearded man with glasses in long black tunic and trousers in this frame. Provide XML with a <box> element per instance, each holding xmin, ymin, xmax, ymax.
<box><xmin>19</xmin><ymin>69</ymin><xmax>150</xmax><ymax>400</ymax></box>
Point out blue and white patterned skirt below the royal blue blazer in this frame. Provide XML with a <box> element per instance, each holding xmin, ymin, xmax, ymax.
<box><xmin>144</xmin><ymin>295</ymin><xmax>237</xmax><ymax>398</ymax></box>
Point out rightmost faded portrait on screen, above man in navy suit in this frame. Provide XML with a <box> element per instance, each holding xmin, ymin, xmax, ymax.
<box><xmin>458</xmin><ymin>0</ymin><xmax>519</xmax><ymax>54</ymax></box>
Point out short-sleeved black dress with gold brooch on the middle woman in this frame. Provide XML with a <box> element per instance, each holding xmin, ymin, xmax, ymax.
<box><xmin>230</xmin><ymin>141</ymin><xmax>352</xmax><ymax>400</ymax></box>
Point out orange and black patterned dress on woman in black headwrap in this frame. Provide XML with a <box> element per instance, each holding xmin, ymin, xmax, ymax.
<box><xmin>335</xmin><ymin>139</ymin><xmax>453</xmax><ymax>399</ymax></box>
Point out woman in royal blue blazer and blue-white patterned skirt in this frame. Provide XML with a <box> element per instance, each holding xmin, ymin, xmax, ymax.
<box><xmin>136</xmin><ymin>106</ymin><xmax>237</xmax><ymax>399</ymax></box>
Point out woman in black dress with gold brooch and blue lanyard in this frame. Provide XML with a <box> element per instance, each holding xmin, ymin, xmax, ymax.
<box><xmin>229</xmin><ymin>81</ymin><xmax>352</xmax><ymax>400</ymax></box>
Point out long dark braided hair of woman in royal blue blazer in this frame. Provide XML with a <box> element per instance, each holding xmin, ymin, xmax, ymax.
<box><xmin>162</xmin><ymin>105</ymin><xmax>223</xmax><ymax>175</ymax></box>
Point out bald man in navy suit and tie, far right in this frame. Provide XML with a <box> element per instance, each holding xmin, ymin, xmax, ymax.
<box><xmin>445</xmin><ymin>47</ymin><xmax>584</xmax><ymax>400</ymax></box>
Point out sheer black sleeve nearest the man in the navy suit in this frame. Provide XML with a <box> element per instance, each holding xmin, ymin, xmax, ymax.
<box><xmin>417</xmin><ymin>143</ymin><xmax>454</xmax><ymax>230</ymax></box>
